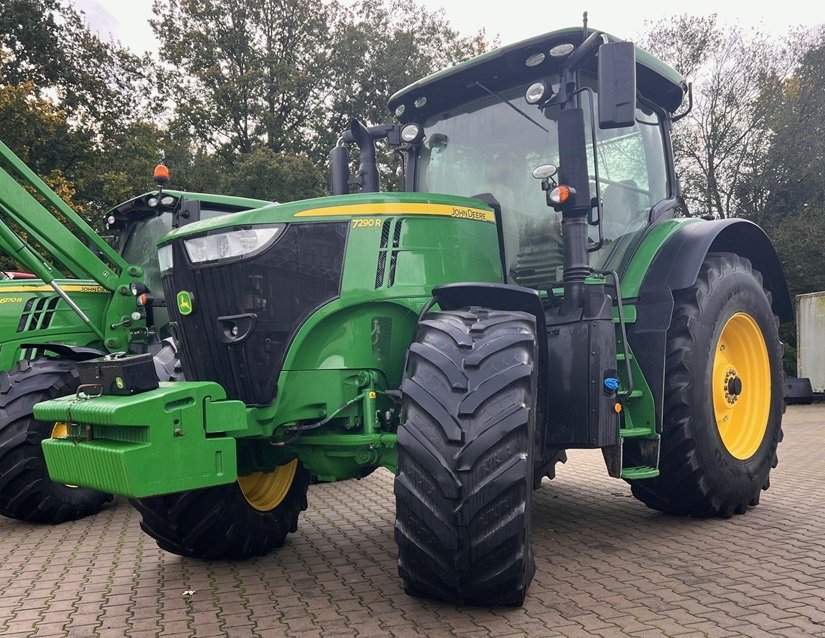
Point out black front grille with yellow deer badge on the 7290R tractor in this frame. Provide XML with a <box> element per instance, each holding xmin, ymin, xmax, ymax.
<box><xmin>163</xmin><ymin>222</ymin><xmax>348</xmax><ymax>405</ymax></box>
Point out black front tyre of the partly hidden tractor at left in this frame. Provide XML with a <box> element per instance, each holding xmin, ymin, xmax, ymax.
<box><xmin>0</xmin><ymin>357</ymin><xmax>112</xmax><ymax>523</ymax></box>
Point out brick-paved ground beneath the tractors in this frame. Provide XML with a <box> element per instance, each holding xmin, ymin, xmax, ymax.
<box><xmin>0</xmin><ymin>404</ymin><xmax>825</xmax><ymax>638</ymax></box>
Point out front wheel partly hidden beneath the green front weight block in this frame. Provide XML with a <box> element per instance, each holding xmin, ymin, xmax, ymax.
<box><xmin>130</xmin><ymin>461</ymin><xmax>309</xmax><ymax>560</ymax></box>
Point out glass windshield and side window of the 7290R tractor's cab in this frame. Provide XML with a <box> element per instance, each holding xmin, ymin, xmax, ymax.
<box><xmin>416</xmin><ymin>77</ymin><xmax>668</xmax><ymax>288</ymax></box>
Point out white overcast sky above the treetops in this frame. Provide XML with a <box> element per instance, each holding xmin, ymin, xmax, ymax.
<box><xmin>72</xmin><ymin>0</ymin><xmax>825</xmax><ymax>52</ymax></box>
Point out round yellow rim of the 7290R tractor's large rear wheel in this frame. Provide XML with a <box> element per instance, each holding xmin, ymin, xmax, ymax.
<box><xmin>713</xmin><ymin>312</ymin><xmax>771</xmax><ymax>460</ymax></box>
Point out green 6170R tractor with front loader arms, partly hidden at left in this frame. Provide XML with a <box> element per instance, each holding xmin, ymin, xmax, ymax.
<box><xmin>0</xmin><ymin>142</ymin><xmax>271</xmax><ymax>523</ymax></box>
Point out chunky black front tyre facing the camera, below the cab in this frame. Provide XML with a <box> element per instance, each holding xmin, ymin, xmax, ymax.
<box><xmin>395</xmin><ymin>308</ymin><xmax>537</xmax><ymax>605</ymax></box>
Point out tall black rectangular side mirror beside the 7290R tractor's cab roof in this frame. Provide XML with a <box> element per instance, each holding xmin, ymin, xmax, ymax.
<box><xmin>599</xmin><ymin>42</ymin><xmax>636</xmax><ymax>129</ymax></box>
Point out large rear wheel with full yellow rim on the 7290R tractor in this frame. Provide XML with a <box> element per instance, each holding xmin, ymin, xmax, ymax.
<box><xmin>631</xmin><ymin>253</ymin><xmax>783</xmax><ymax>517</ymax></box>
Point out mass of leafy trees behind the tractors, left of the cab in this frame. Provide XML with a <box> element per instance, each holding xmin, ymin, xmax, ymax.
<box><xmin>0</xmin><ymin>0</ymin><xmax>489</xmax><ymax>215</ymax></box>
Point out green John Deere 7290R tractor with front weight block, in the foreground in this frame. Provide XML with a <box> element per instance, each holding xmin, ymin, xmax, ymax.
<box><xmin>35</xmin><ymin>29</ymin><xmax>791</xmax><ymax>605</ymax></box>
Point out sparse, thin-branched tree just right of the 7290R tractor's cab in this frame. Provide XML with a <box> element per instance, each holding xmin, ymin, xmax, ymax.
<box><xmin>643</xmin><ymin>15</ymin><xmax>792</xmax><ymax>218</ymax></box>
